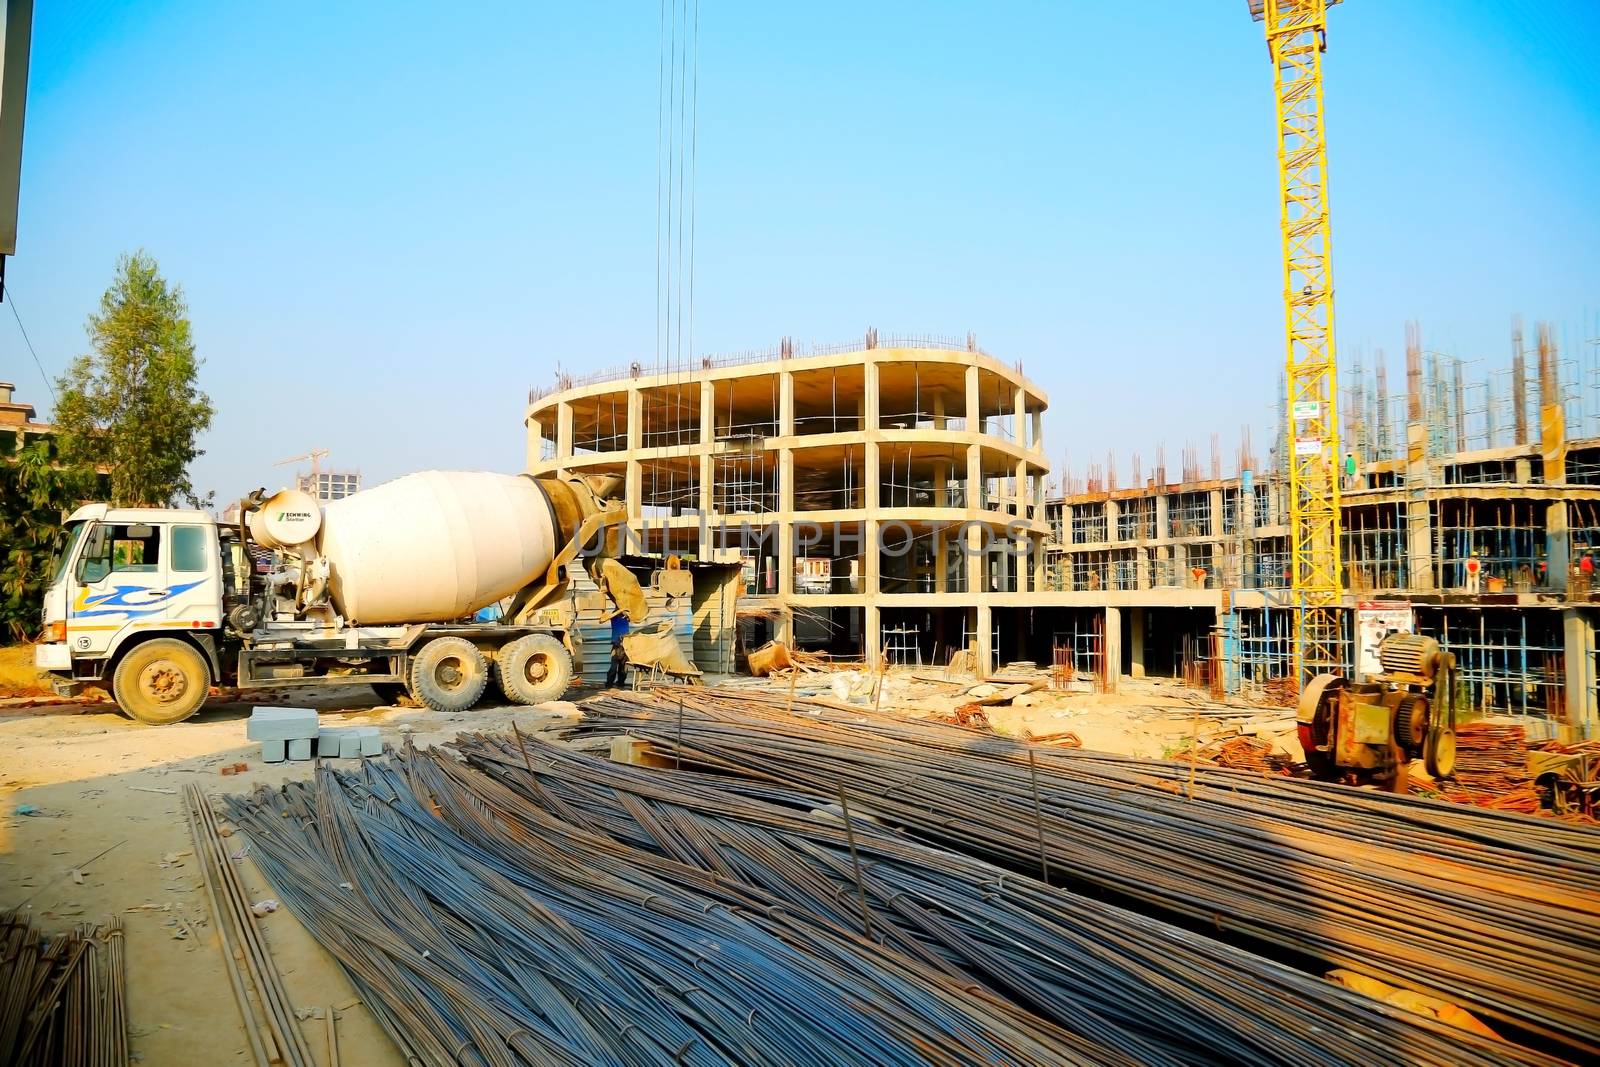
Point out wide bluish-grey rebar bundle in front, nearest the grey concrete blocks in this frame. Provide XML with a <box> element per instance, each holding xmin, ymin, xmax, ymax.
<box><xmin>232</xmin><ymin>758</ymin><xmax>1139</xmax><ymax>1065</ymax></box>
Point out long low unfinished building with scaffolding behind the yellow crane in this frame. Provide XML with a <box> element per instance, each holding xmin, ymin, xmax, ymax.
<box><xmin>1043</xmin><ymin>316</ymin><xmax>1600</xmax><ymax>734</ymax></box>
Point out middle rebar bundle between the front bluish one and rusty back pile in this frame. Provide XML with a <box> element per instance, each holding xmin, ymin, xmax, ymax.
<box><xmin>456</xmin><ymin>736</ymin><xmax>1561</xmax><ymax>1064</ymax></box>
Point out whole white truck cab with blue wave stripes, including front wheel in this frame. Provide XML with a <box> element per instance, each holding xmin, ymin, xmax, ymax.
<box><xmin>35</xmin><ymin>504</ymin><xmax>226</xmax><ymax>723</ymax></box>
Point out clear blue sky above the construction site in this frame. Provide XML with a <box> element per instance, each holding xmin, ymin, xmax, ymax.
<box><xmin>0</xmin><ymin>0</ymin><xmax>1600</xmax><ymax>499</ymax></box>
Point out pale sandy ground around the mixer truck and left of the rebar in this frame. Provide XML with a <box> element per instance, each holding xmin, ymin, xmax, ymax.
<box><xmin>0</xmin><ymin>689</ymin><xmax>592</xmax><ymax>1067</ymax></box>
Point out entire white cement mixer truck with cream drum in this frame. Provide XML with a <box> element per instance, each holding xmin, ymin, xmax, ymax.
<box><xmin>35</xmin><ymin>470</ymin><xmax>630</xmax><ymax>725</ymax></box>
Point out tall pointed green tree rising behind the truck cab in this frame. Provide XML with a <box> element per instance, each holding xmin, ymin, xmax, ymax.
<box><xmin>54</xmin><ymin>250</ymin><xmax>213</xmax><ymax>507</ymax></box>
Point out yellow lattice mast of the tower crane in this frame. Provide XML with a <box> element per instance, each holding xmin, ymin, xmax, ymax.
<box><xmin>1246</xmin><ymin>0</ymin><xmax>1342</xmax><ymax>685</ymax></box>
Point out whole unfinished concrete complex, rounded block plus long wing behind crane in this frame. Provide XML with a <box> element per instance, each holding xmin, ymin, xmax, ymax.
<box><xmin>526</xmin><ymin>321</ymin><xmax>1600</xmax><ymax>739</ymax></box>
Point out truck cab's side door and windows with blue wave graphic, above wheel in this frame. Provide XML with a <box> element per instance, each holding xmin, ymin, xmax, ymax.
<box><xmin>67</xmin><ymin>523</ymin><xmax>218</xmax><ymax>657</ymax></box>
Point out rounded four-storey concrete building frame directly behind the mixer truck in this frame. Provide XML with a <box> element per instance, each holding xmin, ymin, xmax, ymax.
<box><xmin>526</xmin><ymin>331</ymin><xmax>1048</xmax><ymax>664</ymax></box>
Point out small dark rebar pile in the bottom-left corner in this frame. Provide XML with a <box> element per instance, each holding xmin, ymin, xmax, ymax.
<box><xmin>0</xmin><ymin>912</ymin><xmax>128</xmax><ymax>1067</ymax></box>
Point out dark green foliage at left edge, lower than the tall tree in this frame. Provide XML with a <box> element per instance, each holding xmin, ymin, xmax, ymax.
<box><xmin>0</xmin><ymin>438</ymin><xmax>96</xmax><ymax>640</ymax></box>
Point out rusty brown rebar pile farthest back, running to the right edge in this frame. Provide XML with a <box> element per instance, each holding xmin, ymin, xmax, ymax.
<box><xmin>586</xmin><ymin>689</ymin><xmax>1600</xmax><ymax>1059</ymax></box>
